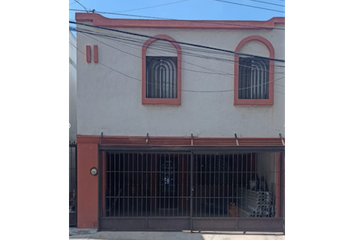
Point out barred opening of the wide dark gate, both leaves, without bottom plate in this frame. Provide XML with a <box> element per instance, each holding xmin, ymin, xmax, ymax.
<box><xmin>102</xmin><ymin>151</ymin><xmax>276</xmax><ymax>222</ymax></box>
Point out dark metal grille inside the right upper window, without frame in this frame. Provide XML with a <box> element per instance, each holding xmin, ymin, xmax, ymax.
<box><xmin>238</xmin><ymin>57</ymin><xmax>269</xmax><ymax>99</ymax></box>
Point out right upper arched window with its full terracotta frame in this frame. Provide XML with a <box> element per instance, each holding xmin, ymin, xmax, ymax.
<box><xmin>234</xmin><ymin>36</ymin><xmax>274</xmax><ymax>105</ymax></box>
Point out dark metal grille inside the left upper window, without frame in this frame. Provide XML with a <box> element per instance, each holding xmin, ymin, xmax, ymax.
<box><xmin>146</xmin><ymin>56</ymin><xmax>177</xmax><ymax>98</ymax></box>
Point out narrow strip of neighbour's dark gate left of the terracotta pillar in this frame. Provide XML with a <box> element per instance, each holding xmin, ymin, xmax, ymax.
<box><xmin>68</xmin><ymin>143</ymin><xmax>77</xmax><ymax>227</ymax></box>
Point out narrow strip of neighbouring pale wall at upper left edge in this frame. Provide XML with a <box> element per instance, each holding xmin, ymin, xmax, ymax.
<box><xmin>68</xmin><ymin>30</ymin><xmax>77</xmax><ymax>142</ymax></box>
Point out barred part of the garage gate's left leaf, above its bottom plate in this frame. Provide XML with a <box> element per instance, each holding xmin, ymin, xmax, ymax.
<box><xmin>103</xmin><ymin>152</ymin><xmax>191</xmax><ymax>217</ymax></box>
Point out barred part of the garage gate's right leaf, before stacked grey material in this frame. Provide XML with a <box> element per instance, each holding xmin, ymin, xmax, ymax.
<box><xmin>193</xmin><ymin>153</ymin><xmax>275</xmax><ymax>218</ymax></box>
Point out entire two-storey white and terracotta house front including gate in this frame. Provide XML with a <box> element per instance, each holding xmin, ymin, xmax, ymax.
<box><xmin>76</xmin><ymin>13</ymin><xmax>285</xmax><ymax>231</ymax></box>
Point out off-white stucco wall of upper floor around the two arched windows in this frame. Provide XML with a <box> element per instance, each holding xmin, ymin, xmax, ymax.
<box><xmin>77</xmin><ymin>21</ymin><xmax>285</xmax><ymax>137</ymax></box>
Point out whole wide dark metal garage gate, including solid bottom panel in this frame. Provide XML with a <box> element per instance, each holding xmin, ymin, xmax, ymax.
<box><xmin>99</xmin><ymin>149</ymin><xmax>284</xmax><ymax>231</ymax></box>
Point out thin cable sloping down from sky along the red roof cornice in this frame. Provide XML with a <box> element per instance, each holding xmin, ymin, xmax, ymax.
<box><xmin>68</xmin><ymin>8</ymin><xmax>286</xmax><ymax>31</ymax></box>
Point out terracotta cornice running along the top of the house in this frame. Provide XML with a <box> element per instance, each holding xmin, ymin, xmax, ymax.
<box><xmin>75</xmin><ymin>13</ymin><xmax>286</xmax><ymax>29</ymax></box>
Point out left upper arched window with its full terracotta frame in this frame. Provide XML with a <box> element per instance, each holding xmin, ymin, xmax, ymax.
<box><xmin>142</xmin><ymin>35</ymin><xmax>182</xmax><ymax>105</ymax></box>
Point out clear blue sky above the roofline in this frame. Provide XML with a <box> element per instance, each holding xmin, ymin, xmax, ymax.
<box><xmin>67</xmin><ymin>0</ymin><xmax>286</xmax><ymax>20</ymax></box>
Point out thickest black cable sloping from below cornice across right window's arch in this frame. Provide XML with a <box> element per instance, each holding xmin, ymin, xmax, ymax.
<box><xmin>68</xmin><ymin>20</ymin><xmax>286</xmax><ymax>63</ymax></box>
